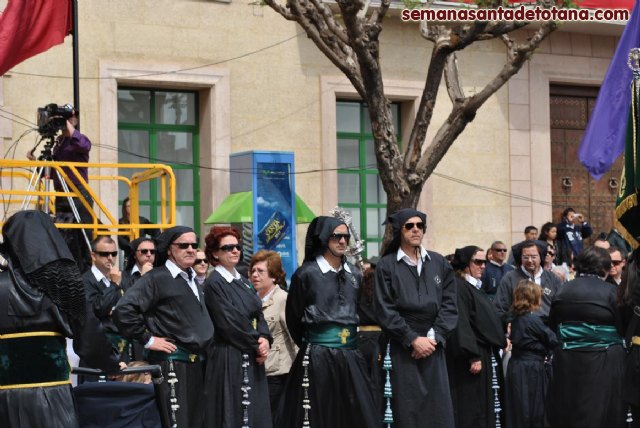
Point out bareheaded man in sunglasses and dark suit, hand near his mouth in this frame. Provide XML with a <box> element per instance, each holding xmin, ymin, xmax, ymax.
<box><xmin>81</xmin><ymin>236</ymin><xmax>129</xmax><ymax>365</ymax></box>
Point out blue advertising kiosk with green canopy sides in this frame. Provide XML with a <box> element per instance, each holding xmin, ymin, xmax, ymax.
<box><xmin>205</xmin><ymin>151</ymin><xmax>314</xmax><ymax>281</ymax></box>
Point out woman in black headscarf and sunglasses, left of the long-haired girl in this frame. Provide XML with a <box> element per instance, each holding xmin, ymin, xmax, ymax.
<box><xmin>446</xmin><ymin>245</ymin><xmax>506</xmax><ymax>428</ymax></box>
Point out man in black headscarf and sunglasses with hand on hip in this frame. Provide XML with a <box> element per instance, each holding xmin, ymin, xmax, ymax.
<box><xmin>113</xmin><ymin>226</ymin><xmax>213</xmax><ymax>427</ymax></box>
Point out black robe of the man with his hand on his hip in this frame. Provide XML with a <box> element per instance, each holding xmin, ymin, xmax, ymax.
<box><xmin>113</xmin><ymin>266</ymin><xmax>213</xmax><ymax>428</ymax></box>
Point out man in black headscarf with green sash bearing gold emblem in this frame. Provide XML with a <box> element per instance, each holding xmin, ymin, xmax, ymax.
<box><xmin>274</xmin><ymin>216</ymin><xmax>381</xmax><ymax>428</ymax></box>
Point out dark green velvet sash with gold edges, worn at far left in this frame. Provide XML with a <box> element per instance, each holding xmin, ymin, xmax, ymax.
<box><xmin>0</xmin><ymin>331</ymin><xmax>71</xmax><ymax>389</ymax></box>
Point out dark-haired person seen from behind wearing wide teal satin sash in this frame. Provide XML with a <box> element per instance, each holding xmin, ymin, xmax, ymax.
<box><xmin>549</xmin><ymin>247</ymin><xmax>626</xmax><ymax>428</ymax></box>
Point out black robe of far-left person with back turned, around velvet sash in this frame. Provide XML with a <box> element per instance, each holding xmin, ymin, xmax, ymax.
<box><xmin>0</xmin><ymin>262</ymin><xmax>118</xmax><ymax>428</ymax></box>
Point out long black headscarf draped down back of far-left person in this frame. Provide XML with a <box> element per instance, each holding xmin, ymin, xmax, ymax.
<box><xmin>2</xmin><ymin>210</ymin><xmax>86</xmax><ymax>321</ymax></box>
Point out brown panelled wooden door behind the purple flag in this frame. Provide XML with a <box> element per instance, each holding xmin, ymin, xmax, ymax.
<box><xmin>550</xmin><ymin>85</ymin><xmax>623</xmax><ymax>243</ymax></box>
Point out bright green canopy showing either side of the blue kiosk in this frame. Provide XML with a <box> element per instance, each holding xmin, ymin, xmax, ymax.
<box><xmin>205</xmin><ymin>191</ymin><xmax>316</xmax><ymax>224</ymax></box>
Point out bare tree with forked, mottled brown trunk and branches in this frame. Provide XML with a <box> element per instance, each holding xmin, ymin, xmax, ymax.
<box><xmin>264</xmin><ymin>0</ymin><xmax>556</xmax><ymax>246</ymax></box>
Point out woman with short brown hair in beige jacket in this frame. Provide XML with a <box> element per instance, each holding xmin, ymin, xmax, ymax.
<box><xmin>249</xmin><ymin>250</ymin><xmax>298</xmax><ymax>422</ymax></box>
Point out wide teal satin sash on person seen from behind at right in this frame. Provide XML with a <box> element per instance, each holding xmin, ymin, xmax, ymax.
<box><xmin>558</xmin><ymin>323</ymin><xmax>623</xmax><ymax>349</ymax></box>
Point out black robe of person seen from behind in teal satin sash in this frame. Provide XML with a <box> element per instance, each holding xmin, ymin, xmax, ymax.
<box><xmin>549</xmin><ymin>276</ymin><xmax>626</xmax><ymax>428</ymax></box>
